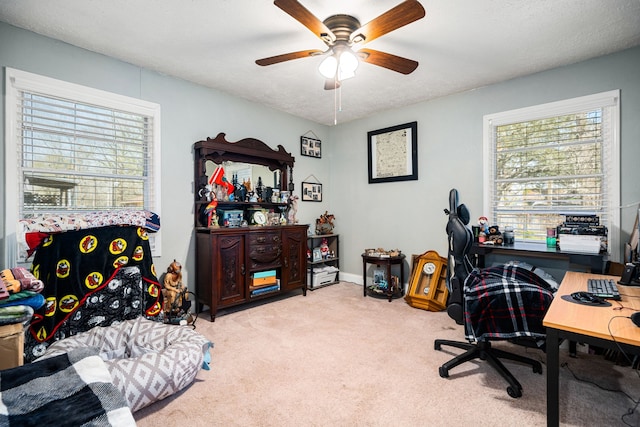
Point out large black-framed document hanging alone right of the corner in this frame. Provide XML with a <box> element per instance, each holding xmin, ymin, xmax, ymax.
<box><xmin>367</xmin><ymin>122</ymin><xmax>418</xmax><ymax>184</ymax></box>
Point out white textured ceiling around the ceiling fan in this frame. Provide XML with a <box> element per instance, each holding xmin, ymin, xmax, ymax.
<box><xmin>0</xmin><ymin>0</ymin><xmax>640</xmax><ymax>125</ymax></box>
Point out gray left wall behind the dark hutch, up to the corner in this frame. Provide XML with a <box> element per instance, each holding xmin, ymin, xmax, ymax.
<box><xmin>0</xmin><ymin>22</ymin><xmax>330</xmax><ymax>288</ymax></box>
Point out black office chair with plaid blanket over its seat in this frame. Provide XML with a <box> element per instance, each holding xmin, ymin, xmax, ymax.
<box><xmin>434</xmin><ymin>189</ymin><xmax>553</xmax><ymax>398</ymax></box>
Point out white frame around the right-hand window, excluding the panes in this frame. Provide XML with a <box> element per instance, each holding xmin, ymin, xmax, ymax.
<box><xmin>483</xmin><ymin>89</ymin><xmax>621</xmax><ymax>260</ymax></box>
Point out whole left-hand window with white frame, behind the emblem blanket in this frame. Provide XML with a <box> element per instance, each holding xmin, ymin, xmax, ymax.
<box><xmin>5</xmin><ymin>69</ymin><xmax>160</xmax><ymax>260</ymax></box>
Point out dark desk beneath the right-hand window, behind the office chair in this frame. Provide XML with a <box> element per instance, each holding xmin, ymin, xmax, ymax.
<box><xmin>470</xmin><ymin>241</ymin><xmax>608</xmax><ymax>273</ymax></box>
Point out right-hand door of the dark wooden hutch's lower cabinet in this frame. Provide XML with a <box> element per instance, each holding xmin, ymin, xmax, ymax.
<box><xmin>282</xmin><ymin>227</ymin><xmax>307</xmax><ymax>289</ymax></box>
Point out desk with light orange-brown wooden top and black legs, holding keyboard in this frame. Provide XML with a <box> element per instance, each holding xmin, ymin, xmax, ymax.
<box><xmin>543</xmin><ymin>271</ymin><xmax>640</xmax><ymax>426</ymax></box>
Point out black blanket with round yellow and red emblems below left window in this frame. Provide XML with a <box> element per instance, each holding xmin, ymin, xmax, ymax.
<box><xmin>25</xmin><ymin>226</ymin><xmax>162</xmax><ymax>361</ymax></box>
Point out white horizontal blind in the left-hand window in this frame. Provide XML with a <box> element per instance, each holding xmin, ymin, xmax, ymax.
<box><xmin>16</xmin><ymin>91</ymin><xmax>154</xmax><ymax>217</ymax></box>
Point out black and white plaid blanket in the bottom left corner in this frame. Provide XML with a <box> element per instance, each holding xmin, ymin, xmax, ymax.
<box><xmin>0</xmin><ymin>348</ymin><xmax>136</xmax><ymax>427</ymax></box>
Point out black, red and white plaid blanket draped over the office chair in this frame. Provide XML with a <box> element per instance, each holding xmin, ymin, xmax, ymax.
<box><xmin>464</xmin><ymin>265</ymin><xmax>554</xmax><ymax>342</ymax></box>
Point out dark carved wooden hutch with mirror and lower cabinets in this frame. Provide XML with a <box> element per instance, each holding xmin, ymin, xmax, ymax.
<box><xmin>194</xmin><ymin>133</ymin><xmax>308</xmax><ymax>321</ymax></box>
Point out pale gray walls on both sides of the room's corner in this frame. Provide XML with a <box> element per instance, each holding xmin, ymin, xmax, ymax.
<box><xmin>0</xmin><ymin>23</ymin><xmax>640</xmax><ymax>287</ymax></box>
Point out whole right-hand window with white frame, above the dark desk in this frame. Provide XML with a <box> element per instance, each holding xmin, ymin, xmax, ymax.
<box><xmin>484</xmin><ymin>90</ymin><xmax>620</xmax><ymax>259</ymax></box>
